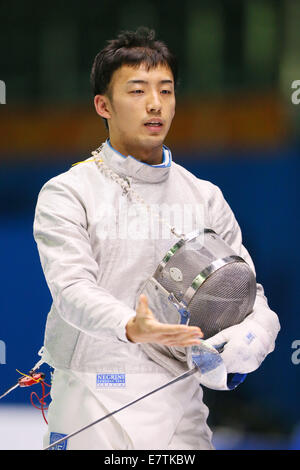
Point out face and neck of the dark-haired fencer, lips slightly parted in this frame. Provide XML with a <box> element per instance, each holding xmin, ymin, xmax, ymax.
<box><xmin>95</xmin><ymin>64</ymin><xmax>175</xmax><ymax>165</ymax></box>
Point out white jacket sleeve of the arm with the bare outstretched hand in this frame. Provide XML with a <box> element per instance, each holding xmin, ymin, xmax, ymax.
<box><xmin>34</xmin><ymin>177</ymin><xmax>136</xmax><ymax>341</ymax></box>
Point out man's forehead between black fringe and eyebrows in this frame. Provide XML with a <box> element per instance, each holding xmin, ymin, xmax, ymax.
<box><xmin>110</xmin><ymin>64</ymin><xmax>174</xmax><ymax>87</ymax></box>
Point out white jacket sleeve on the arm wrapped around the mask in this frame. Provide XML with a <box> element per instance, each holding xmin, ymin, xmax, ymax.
<box><xmin>208</xmin><ymin>186</ymin><xmax>280</xmax><ymax>354</ymax></box>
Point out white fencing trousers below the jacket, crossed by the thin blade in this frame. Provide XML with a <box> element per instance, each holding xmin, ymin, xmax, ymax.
<box><xmin>44</xmin><ymin>369</ymin><xmax>214</xmax><ymax>450</ymax></box>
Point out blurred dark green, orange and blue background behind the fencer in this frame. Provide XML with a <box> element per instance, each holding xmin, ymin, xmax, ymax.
<box><xmin>0</xmin><ymin>0</ymin><xmax>300</xmax><ymax>449</ymax></box>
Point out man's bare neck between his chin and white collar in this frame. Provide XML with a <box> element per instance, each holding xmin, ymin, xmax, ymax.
<box><xmin>109</xmin><ymin>137</ymin><xmax>163</xmax><ymax>165</ymax></box>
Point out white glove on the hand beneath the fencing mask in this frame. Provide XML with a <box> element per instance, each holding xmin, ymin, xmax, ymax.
<box><xmin>205</xmin><ymin>318</ymin><xmax>275</xmax><ymax>374</ymax></box>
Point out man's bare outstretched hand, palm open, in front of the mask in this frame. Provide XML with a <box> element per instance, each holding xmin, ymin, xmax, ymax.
<box><xmin>126</xmin><ymin>294</ymin><xmax>203</xmax><ymax>347</ymax></box>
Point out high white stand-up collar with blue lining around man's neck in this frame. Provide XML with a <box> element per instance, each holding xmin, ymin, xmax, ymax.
<box><xmin>101</xmin><ymin>139</ymin><xmax>172</xmax><ymax>183</ymax></box>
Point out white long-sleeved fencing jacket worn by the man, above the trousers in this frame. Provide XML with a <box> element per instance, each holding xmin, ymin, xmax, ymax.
<box><xmin>34</xmin><ymin>140</ymin><xmax>280</xmax><ymax>373</ymax></box>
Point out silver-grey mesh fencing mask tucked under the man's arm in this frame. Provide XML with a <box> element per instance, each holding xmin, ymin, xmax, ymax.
<box><xmin>140</xmin><ymin>229</ymin><xmax>256</xmax><ymax>390</ymax></box>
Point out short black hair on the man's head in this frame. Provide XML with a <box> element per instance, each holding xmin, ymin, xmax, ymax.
<box><xmin>90</xmin><ymin>26</ymin><xmax>178</xmax><ymax>129</ymax></box>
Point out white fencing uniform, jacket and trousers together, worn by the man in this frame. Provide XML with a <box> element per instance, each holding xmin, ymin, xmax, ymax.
<box><xmin>34</xmin><ymin>140</ymin><xmax>279</xmax><ymax>449</ymax></box>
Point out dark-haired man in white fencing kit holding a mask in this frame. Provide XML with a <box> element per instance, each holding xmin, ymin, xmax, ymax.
<box><xmin>34</xmin><ymin>28</ymin><xmax>279</xmax><ymax>450</ymax></box>
